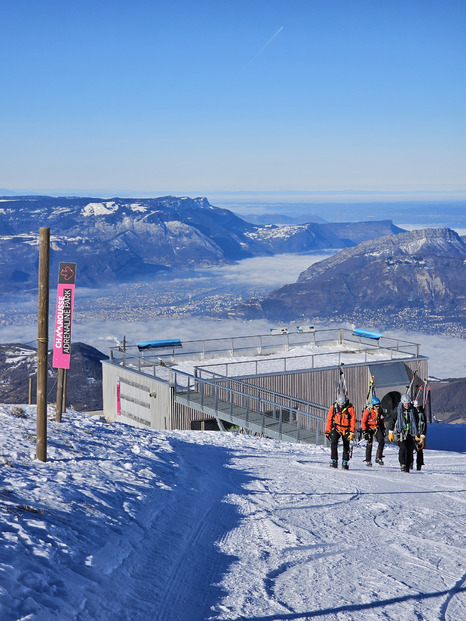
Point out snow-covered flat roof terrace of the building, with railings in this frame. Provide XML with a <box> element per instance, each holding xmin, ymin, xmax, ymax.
<box><xmin>111</xmin><ymin>328</ymin><xmax>419</xmax><ymax>380</ymax></box>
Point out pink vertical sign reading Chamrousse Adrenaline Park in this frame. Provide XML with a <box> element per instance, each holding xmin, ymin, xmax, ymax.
<box><xmin>52</xmin><ymin>263</ymin><xmax>76</xmax><ymax>369</ymax></box>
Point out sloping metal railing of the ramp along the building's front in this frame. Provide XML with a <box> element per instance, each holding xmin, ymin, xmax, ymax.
<box><xmin>169</xmin><ymin>369</ymin><xmax>327</xmax><ymax>444</ymax></box>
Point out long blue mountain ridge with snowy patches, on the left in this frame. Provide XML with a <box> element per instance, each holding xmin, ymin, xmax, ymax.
<box><xmin>0</xmin><ymin>196</ymin><xmax>401</xmax><ymax>293</ymax></box>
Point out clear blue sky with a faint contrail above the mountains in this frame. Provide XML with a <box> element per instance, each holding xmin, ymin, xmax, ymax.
<box><xmin>0</xmin><ymin>0</ymin><xmax>466</xmax><ymax>196</ymax></box>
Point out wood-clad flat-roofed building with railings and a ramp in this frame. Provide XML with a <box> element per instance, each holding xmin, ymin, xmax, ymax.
<box><xmin>102</xmin><ymin>326</ymin><xmax>428</xmax><ymax>444</ymax></box>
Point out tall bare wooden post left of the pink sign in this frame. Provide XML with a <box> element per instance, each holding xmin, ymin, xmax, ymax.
<box><xmin>36</xmin><ymin>227</ymin><xmax>50</xmax><ymax>461</ymax></box>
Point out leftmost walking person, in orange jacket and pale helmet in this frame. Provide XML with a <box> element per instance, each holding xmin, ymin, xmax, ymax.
<box><xmin>325</xmin><ymin>392</ymin><xmax>356</xmax><ymax>470</ymax></box>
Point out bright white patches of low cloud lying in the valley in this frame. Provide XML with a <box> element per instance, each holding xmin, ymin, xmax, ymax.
<box><xmin>0</xmin><ymin>251</ymin><xmax>466</xmax><ymax>379</ymax></box>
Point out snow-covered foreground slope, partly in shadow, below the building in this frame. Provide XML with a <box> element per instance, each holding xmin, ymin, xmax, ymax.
<box><xmin>0</xmin><ymin>405</ymin><xmax>466</xmax><ymax>621</ymax></box>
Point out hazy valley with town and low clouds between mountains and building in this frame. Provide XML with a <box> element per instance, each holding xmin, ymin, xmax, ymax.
<box><xmin>0</xmin><ymin>251</ymin><xmax>466</xmax><ymax>378</ymax></box>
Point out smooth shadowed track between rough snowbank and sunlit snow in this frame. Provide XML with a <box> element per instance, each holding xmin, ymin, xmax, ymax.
<box><xmin>113</xmin><ymin>445</ymin><xmax>248</xmax><ymax>621</ymax></box>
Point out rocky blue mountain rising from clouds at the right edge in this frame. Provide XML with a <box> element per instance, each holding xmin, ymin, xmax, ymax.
<box><xmin>238</xmin><ymin>228</ymin><xmax>466</xmax><ymax>336</ymax></box>
